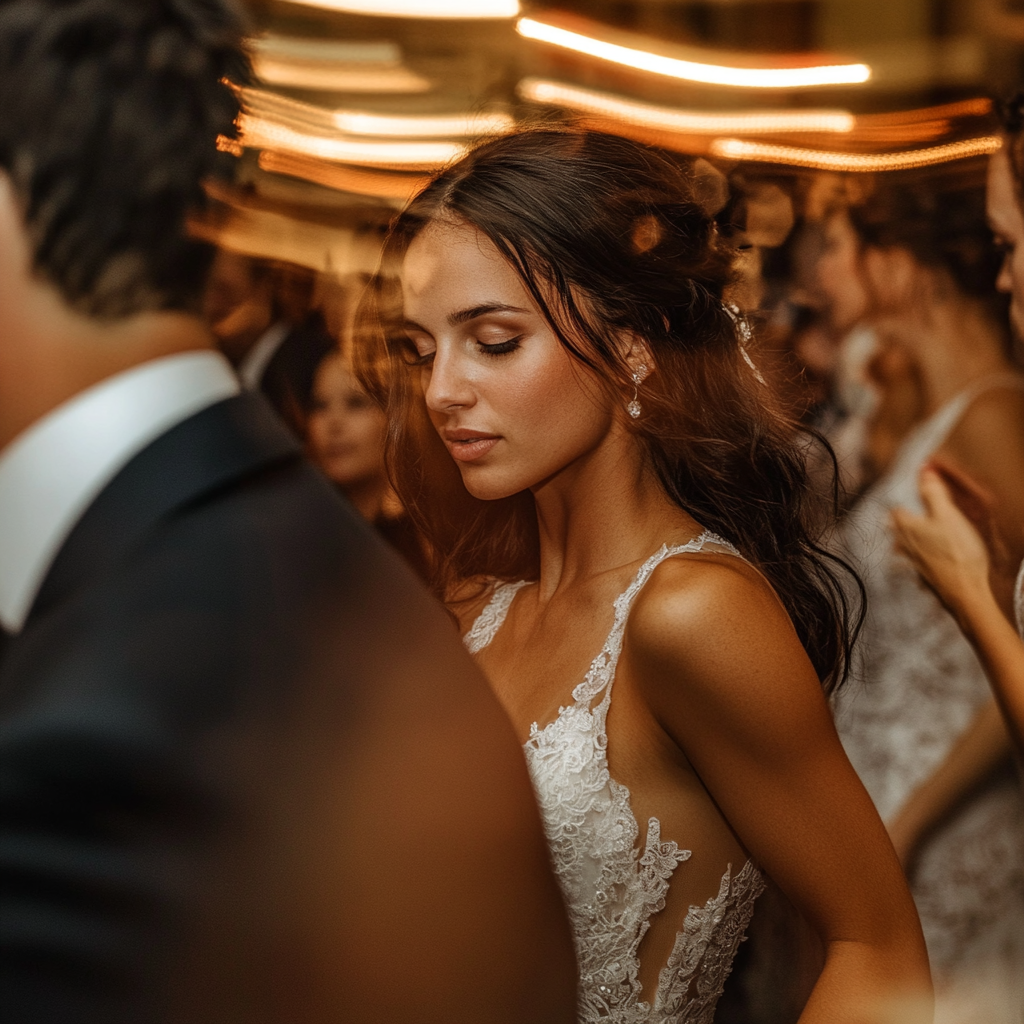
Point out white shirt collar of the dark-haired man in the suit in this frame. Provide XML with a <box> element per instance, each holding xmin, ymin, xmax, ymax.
<box><xmin>0</xmin><ymin>351</ymin><xmax>240</xmax><ymax>633</ymax></box>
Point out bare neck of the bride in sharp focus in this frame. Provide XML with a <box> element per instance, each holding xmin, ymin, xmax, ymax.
<box><xmin>534</xmin><ymin>429</ymin><xmax>698</xmax><ymax>601</ymax></box>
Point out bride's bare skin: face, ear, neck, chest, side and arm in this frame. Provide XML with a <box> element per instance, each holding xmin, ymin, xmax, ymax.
<box><xmin>403</xmin><ymin>222</ymin><xmax>931</xmax><ymax>1024</ymax></box>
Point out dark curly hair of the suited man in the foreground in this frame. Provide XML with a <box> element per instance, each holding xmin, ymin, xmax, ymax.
<box><xmin>0</xmin><ymin>0</ymin><xmax>249</xmax><ymax>318</ymax></box>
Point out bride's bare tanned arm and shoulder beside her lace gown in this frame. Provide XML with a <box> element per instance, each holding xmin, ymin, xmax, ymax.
<box><xmin>628</xmin><ymin>556</ymin><xmax>931</xmax><ymax>1024</ymax></box>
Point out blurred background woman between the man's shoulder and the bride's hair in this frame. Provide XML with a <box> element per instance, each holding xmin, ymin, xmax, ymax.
<box><xmin>306</xmin><ymin>350</ymin><xmax>428</xmax><ymax>578</ymax></box>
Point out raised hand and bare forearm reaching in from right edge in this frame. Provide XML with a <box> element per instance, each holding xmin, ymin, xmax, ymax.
<box><xmin>893</xmin><ymin>469</ymin><xmax>1024</xmax><ymax>751</ymax></box>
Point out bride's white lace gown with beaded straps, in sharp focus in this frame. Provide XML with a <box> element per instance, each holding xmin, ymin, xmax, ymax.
<box><xmin>465</xmin><ymin>532</ymin><xmax>764</xmax><ymax>1024</ymax></box>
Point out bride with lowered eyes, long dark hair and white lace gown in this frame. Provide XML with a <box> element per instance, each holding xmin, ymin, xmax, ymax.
<box><xmin>361</xmin><ymin>130</ymin><xmax>931</xmax><ymax>1024</ymax></box>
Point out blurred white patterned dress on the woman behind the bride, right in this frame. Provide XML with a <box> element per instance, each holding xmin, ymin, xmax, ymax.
<box><xmin>836</xmin><ymin>378</ymin><xmax>1024</xmax><ymax>1024</ymax></box>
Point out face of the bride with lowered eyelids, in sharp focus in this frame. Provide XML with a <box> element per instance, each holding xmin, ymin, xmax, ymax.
<box><xmin>402</xmin><ymin>221</ymin><xmax>615</xmax><ymax>500</ymax></box>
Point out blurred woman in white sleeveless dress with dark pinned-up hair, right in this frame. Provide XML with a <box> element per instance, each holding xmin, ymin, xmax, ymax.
<box><xmin>838</xmin><ymin>163</ymin><xmax>1024</xmax><ymax>1024</ymax></box>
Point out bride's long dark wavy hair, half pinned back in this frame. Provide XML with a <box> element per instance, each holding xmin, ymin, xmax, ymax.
<box><xmin>356</xmin><ymin>123</ymin><xmax>862</xmax><ymax>692</ymax></box>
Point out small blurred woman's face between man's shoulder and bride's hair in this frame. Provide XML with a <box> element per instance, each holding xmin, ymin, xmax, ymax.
<box><xmin>307</xmin><ymin>355</ymin><xmax>387</xmax><ymax>487</ymax></box>
